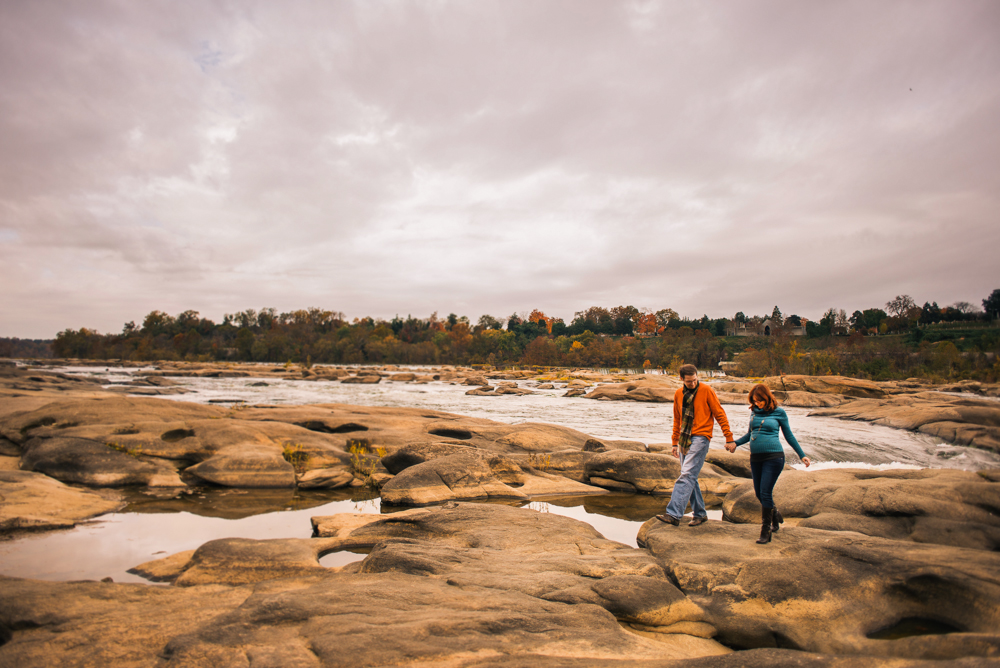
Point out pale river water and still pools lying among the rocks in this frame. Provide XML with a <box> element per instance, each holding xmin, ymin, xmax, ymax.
<box><xmin>0</xmin><ymin>367</ymin><xmax>1000</xmax><ymax>582</ymax></box>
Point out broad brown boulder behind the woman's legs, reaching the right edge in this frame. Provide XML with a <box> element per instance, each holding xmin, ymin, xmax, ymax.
<box><xmin>723</xmin><ymin>469</ymin><xmax>1000</xmax><ymax>550</ymax></box>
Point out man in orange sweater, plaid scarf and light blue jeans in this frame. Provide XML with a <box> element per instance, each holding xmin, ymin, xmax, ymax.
<box><xmin>656</xmin><ymin>364</ymin><xmax>736</xmax><ymax>527</ymax></box>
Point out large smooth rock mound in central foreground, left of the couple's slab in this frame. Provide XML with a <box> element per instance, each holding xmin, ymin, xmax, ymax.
<box><xmin>313</xmin><ymin>504</ymin><xmax>726</xmax><ymax>654</ymax></box>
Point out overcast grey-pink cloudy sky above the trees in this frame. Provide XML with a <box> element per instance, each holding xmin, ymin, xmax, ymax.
<box><xmin>0</xmin><ymin>0</ymin><xmax>1000</xmax><ymax>338</ymax></box>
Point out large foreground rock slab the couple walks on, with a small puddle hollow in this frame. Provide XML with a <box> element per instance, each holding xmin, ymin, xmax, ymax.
<box><xmin>638</xmin><ymin>519</ymin><xmax>1000</xmax><ymax>659</ymax></box>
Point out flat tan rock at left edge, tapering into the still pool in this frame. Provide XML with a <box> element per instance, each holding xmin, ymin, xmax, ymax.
<box><xmin>0</xmin><ymin>471</ymin><xmax>123</xmax><ymax>532</ymax></box>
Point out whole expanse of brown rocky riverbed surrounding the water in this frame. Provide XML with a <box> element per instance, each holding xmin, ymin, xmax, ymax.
<box><xmin>0</xmin><ymin>365</ymin><xmax>1000</xmax><ymax>666</ymax></box>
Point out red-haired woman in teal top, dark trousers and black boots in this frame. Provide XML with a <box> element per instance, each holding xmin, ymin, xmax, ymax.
<box><xmin>726</xmin><ymin>384</ymin><xmax>812</xmax><ymax>545</ymax></box>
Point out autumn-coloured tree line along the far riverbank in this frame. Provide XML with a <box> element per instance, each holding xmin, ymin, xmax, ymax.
<box><xmin>37</xmin><ymin>290</ymin><xmax>1000</xmax><ymax>377</ymax></box>
